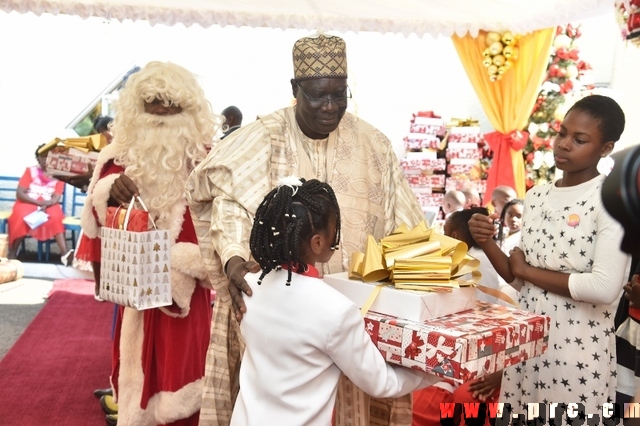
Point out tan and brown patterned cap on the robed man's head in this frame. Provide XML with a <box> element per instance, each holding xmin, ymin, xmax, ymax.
<box><xmin>293</xmin><ymin>34</ymin><xmax>347</xmax><ymax>80</ymax></box>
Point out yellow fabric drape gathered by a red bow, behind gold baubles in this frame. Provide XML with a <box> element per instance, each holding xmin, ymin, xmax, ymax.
<box><xmin>452</xmin><ymin>28</ymin><xmax>556</xmax><ymax>198</ymax></box>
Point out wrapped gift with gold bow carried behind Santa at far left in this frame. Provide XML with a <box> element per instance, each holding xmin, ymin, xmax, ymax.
<box><xmin>40</xmin><ymin>134</ymin><xmax>107</xmax><ymax>176</ymax></box>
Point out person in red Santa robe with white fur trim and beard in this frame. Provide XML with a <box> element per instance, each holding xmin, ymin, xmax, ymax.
<box><xmin>82</xmin><ymin>62</ymin><xmax>222</xmax><ymax>426</ymax></box>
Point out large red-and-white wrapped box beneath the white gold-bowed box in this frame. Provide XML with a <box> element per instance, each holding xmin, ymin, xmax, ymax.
<box><xmin>364</xmin><ymin>301</ymin><xmax>551</xmax><ymax>383</ymax></box>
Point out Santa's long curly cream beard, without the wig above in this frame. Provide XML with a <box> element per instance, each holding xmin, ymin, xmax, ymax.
<box><xmin>119</xmin><ymin>114</ymin><xmax>197</xmax><ymax>228</ymax></box>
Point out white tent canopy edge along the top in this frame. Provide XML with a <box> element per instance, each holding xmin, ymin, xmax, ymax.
<box><xmin>0</xmin><ymin>0</ymin><xmax>614</xmax><ymax>37</ymax></box>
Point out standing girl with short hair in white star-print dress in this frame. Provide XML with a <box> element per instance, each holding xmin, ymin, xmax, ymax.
<box><xmin>469</xmin><ymin>95</ymin><xmax>630</xmax><ymax>413</ymax></box>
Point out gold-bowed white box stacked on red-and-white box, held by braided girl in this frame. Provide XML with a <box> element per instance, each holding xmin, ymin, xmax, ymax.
<box><xmin>324</xmin><ymin>223</ymin><xmax>550</xmax><ymax>383</ymax></box>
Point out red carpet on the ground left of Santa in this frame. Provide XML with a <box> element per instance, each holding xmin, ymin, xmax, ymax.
<box><xmin>0</xmin><ymin>280</ymin><xmax>113</xmax><ymax>426</ymax></box>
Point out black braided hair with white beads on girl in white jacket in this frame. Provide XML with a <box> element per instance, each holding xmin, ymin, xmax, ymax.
<box><xmin>249</xmin><ymin>176</ymin><xmax>340</xmax><ymax>285</ymax></box>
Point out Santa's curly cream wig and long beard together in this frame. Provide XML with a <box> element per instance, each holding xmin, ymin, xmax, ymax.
<box><xmin>111</xmin><ymin>62</ymin><xmax>224</xmax><ymax>226</ymax></box>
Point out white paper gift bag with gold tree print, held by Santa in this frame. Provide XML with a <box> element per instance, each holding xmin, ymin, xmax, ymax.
<box><xmin>100</xmin><ymin>199</ymin><xmax>173</xmax><ymax>310</ymax></box>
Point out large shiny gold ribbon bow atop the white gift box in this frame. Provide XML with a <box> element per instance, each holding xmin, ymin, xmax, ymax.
<box><xmin>349</xmin><ymin>222</ymin><xmax>480</xmax><ymax>292</ymax></box>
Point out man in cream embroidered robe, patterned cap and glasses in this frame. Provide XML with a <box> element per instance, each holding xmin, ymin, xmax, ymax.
<box><xmin>187</xmin><ymin>34</ymin><xmax>424</xmax><ymax>426</ymax></box>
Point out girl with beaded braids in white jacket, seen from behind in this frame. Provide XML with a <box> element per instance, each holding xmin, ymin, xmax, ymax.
<box><xmin>231</xmin><ymin>177</ymin><xmax>440</xmax><ymax>426</ymax></box>
